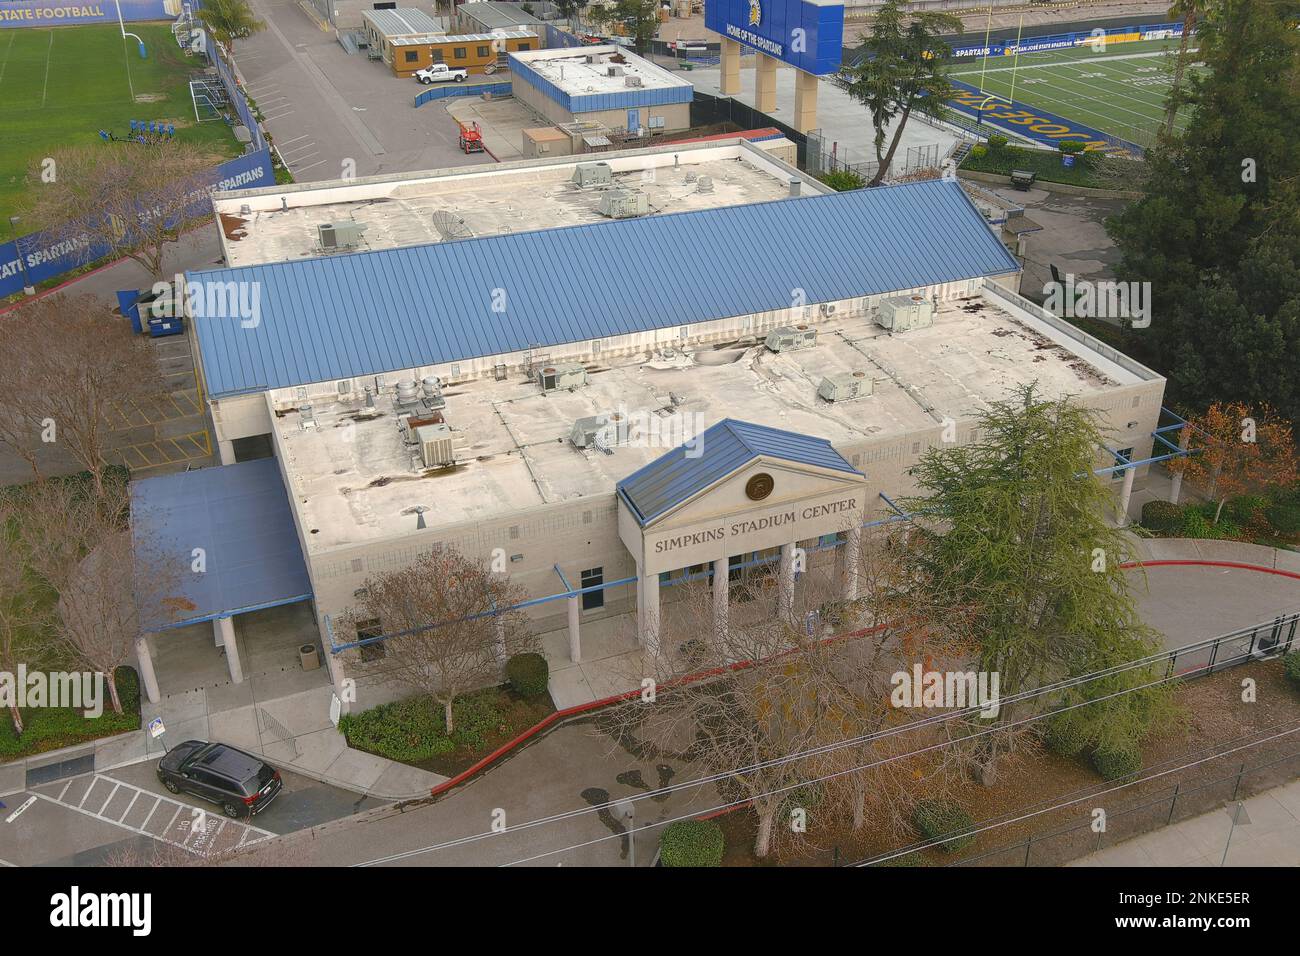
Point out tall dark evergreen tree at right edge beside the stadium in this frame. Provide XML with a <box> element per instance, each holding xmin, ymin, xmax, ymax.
<box><xmin>1108</xmin><ymin>0</ymin><xmax>1300</xmax><ymax>420</ymax></box>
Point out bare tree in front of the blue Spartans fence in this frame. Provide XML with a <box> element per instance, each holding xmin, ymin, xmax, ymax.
<box><xmin>26</xmin><ymin>142</ymin><xmax>220</xmax><ymax>278</ymax></box>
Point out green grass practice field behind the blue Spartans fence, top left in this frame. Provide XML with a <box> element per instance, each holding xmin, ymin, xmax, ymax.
<box><xmin>0</xmin><ymin>23</ymin><xmax>243</xmax><ymax>212</ymax></box>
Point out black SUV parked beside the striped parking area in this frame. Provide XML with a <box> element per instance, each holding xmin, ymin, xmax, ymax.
<box><xmin>159</xmin><ymin>740</ymin><xmax>283</xmax><ymax>817</ymax></box>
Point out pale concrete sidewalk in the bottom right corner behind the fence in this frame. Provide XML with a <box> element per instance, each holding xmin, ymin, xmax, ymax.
<box><xmin>1070</xmin><ymin>780</ymin><xmax>1300</xmax><ymax>866</ymax></box>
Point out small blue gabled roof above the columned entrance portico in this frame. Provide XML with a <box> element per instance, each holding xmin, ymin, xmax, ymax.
<box><xmin>618</xmin><ymin>419</ymin><xmax>862</xmax><ymax>527</ymax></box>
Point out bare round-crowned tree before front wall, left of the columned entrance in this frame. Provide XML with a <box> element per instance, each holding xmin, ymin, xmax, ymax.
<box><xmin>343</xmin><ymin>548</ymin><xmax>538</xmax><ymax>734</ymax></box>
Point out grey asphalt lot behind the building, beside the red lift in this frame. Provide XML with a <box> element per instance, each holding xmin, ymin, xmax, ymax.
<box><xmin>234</xmin><ymin>0</ymin><xmax>501</xmax><ymax>182</ymax></box>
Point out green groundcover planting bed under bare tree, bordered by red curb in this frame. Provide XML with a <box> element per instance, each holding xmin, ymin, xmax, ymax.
<box><xmin>338</xmin><ymin>684</ymin><xmax>555</xmax><ymax>777</ymax></box>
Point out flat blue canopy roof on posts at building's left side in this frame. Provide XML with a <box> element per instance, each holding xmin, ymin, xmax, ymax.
<box><xmin>131</xmin><ymin>458</ymin><xmax>312</xmax><ymax>631</ymax></box>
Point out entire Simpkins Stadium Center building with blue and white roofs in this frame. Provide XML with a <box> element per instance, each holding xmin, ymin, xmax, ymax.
<box><xmin>133</xmin><ymin>139</ymin><xmax>1165</xmax><ymax>706</ymax></box>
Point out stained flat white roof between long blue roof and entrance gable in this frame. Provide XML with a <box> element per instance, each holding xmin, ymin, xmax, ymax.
<box><xmin>274</xmin><ymin>294</ymin><xmax>1143</xmax><ymax>553</ymax></box>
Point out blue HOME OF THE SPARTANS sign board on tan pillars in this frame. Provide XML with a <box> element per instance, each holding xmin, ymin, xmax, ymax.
<box><xmin>705</xmin><ymin>0</ymin><xmax>844</xmax><ymax>77</ymax></box>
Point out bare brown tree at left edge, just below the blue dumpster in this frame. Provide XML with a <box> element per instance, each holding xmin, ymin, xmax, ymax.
<box><xmin>0</xmin><ymin>295</ymin><xmax>166</xmax><ymax>490</ymax></box>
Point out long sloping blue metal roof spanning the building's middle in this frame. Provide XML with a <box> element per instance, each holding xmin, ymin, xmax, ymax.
<box><xmin>189</xmin><ymin>179</ymin><xmax>1019</xmax><ymax>397</ymax></box>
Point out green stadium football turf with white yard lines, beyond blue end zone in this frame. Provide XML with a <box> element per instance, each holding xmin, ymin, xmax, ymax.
<box><xmin>952</xmin><ymin>36</ymin><xmax>1197</xmax><ymax>147</ymax></box>
